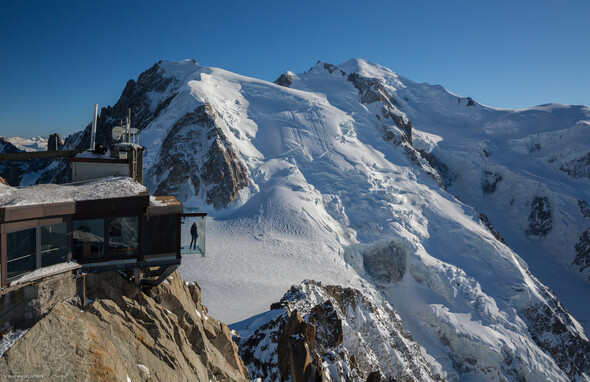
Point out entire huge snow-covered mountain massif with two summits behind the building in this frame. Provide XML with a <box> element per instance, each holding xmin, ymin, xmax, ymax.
<box><xmin>5</xmin><ymin>60</ymin><xmax>590</xmax><ymax>381</ymax></box>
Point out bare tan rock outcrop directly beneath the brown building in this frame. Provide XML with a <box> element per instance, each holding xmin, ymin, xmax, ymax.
<box><xmin>0</xmin><ymin>272</ymin><xmax>249</xmax><ymax>381</ymax></box>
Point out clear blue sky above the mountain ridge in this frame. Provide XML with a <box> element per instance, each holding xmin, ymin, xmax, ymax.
<box><xmin>0</xmin><ymin>0</ymin><xmax>590</xmax><ymax>136</ymax></box>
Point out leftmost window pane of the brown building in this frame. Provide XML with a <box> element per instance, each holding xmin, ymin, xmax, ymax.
<box><xmin>6</xmin><ymin>228</ymin><xmax>37</xmax><ymax>279</ymax></box>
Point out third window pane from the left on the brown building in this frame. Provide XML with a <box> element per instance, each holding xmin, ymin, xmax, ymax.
<box><xmin>72</xmin><ymin>219</ymin><xmax>104</xmax><ymax>260</ymax></box>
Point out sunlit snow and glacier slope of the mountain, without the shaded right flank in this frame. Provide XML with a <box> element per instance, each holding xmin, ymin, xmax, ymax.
<box><xmin>121</xmin><ymin>60</ymin><xmax>590</xmax><ymax>380</ymax></box>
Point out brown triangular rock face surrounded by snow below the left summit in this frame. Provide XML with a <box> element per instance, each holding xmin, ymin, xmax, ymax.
<box><xmin>150</xmin><ymin>104</ymin><xmax>248</xmax><ymax>208</ymax></box>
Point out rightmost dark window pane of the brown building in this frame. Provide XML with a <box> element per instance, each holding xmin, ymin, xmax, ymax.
<box><xmin>109</xmin><ymin>216</ymin><xmax>139</xmax><ymax>257</ymax></box>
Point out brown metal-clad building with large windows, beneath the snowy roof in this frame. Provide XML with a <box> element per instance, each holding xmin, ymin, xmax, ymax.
<box><xmin>0</xmin><ymin>191</ymin><xmax>190</xmax><ymax>287</ymax></box>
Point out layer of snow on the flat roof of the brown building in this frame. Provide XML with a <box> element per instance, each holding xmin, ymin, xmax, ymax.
<box><xmin>0</xmin><ymin>177</ymin><xmax>147</xmax><ymax>207</ymax></box>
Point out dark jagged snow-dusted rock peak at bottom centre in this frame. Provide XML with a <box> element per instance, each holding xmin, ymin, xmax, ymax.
<box><xmin>232</xmin><ymin>280</ymin><xmax>444</xmax><ymax>382</ymax></box>
